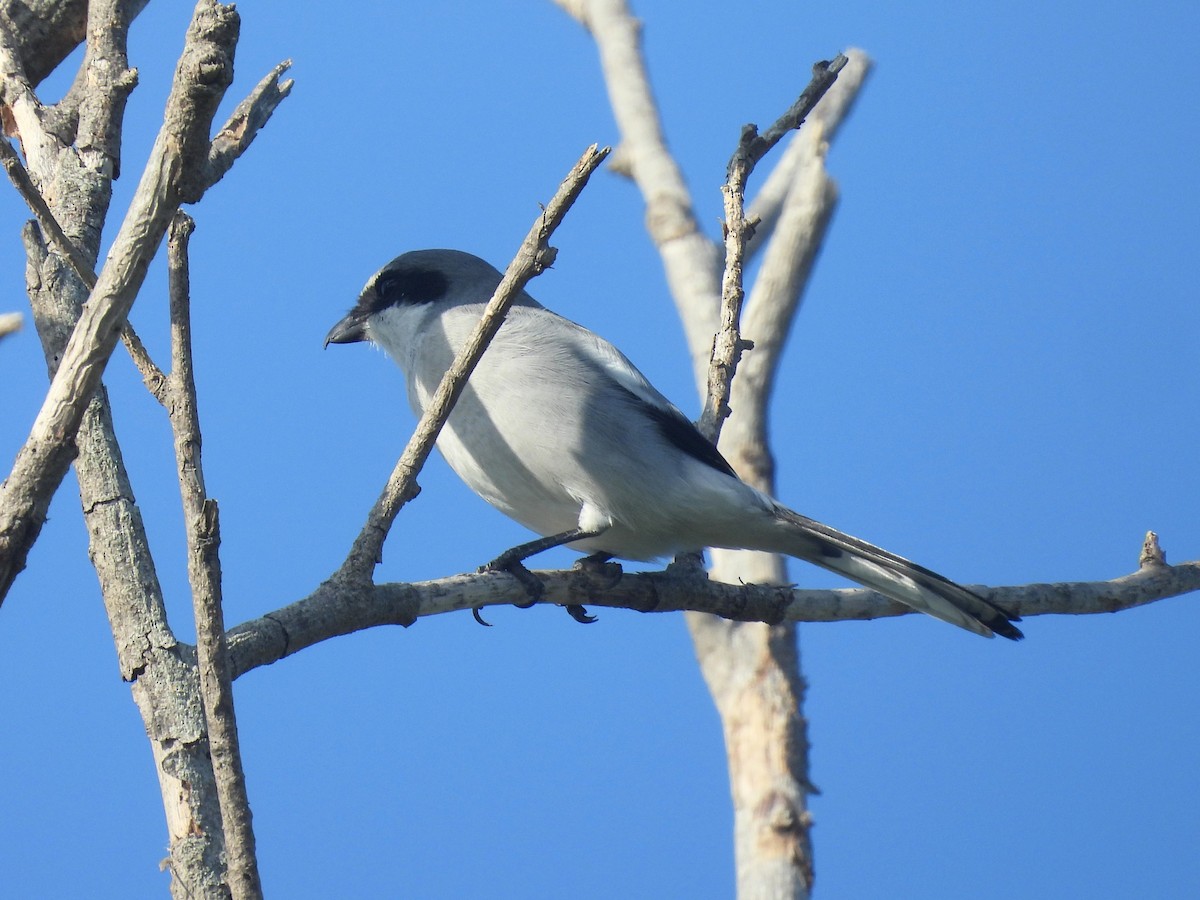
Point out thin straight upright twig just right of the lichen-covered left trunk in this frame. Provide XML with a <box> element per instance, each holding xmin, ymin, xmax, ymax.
<box><xmin>166</xmin><ymin>212</ymin><xmax>263</xmax><ymax>900</ymax></box>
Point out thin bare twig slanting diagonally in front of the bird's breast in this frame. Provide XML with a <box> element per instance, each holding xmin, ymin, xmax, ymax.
<box><xmin>343</xmin><ymin>144</ymin><xmax>610</xmax><ymax>582</ymax></box>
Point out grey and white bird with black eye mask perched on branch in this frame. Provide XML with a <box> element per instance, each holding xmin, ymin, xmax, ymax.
<box><xmin>325</xmin><ymin>250</ymin><xmax>1022</xmax><ymax>640</ymax></box>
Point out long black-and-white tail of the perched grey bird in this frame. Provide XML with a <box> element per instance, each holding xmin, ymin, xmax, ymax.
<box><xmin>778</xmin><ymin>506</ymin><xmax>1025</xmax><ymax>641</ymax></box>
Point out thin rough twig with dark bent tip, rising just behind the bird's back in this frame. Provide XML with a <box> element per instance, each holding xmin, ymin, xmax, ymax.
<box><xmin>698</xmin><ymin>54</ymin><xmax>848</xmax><ymax>443</ymax></box>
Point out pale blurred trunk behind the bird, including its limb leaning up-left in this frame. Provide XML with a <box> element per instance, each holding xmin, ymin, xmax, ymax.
<box><xmin>557</xmin><ymin>0</ymin><xmax>864</xmax><ymax>898</ymax></box>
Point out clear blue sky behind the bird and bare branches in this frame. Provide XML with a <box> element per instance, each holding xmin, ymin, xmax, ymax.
<box><xmin>0</xmin><ymin>0</ymin><xmax>1200</xmax><ymax>900</ymax></box>
